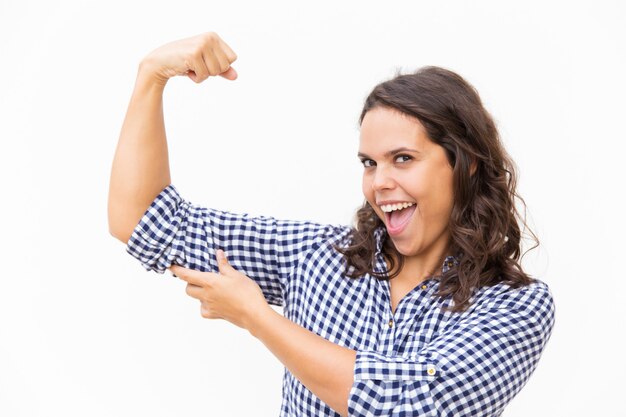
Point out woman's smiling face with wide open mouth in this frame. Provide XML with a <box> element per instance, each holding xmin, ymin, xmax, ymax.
<box><xmin>359</xmin><ymin>107</ymin><xmax>454</xmax><ymax>257</ymax></box>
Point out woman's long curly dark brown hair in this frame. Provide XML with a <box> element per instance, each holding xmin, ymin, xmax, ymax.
<box><xmin>335</xmin><ymin>66</ymin><xmax>539</xmax><ymax>311</ymax></box>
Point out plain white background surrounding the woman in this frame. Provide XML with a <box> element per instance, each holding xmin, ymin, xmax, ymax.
<box><xmin>0</xmin><ymin>0</ymin><xmax>626</xmax><ymax>417</ymax></box>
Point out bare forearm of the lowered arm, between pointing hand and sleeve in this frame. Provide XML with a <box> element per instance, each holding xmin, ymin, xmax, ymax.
<box><xmin>248</xmin><ymin>307</ymin><xmax>356</xmax><ymax>416</ymax></box>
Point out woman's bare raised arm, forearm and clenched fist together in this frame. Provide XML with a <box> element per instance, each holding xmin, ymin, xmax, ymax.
<box><xmin>108</xmin><ymin>32</ymin><xmax>237</xmax><ymax>243</ymax></box>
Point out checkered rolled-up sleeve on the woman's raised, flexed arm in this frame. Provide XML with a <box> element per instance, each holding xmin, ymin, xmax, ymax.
<box><xmin>126</xmin><ymin>184</ymin><xmax>341</xmax><ymax>305</ymax></box>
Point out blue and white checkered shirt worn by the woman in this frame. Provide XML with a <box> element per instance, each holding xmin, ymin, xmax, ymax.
<box><xmin>127</xmin><ymin>185</ymin><xmax>554</xmax><ymax>417</ymax></box>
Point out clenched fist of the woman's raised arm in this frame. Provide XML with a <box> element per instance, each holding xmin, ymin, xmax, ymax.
<box><xmin>141</xmin><ymin>32</ymin><xmax>237</xmax><ymax>85</ymax></box>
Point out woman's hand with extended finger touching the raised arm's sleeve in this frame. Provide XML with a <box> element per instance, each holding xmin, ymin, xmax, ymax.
<box><xmin>169</xmin><ymin>249</ymin><xmax>271</xmax><ymax>331</ymax></box>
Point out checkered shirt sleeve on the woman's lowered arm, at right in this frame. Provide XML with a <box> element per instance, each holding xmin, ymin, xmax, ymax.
<box><xmin>348</xmin><ymin>284</ymin><xmax>554</xmax><ymax>417</ymax></box>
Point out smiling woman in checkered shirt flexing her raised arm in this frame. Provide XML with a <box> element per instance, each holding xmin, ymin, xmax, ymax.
<box><xmin>109</xmin><ymin>33</ymin><xmax>554</xmax><ymax>416</ymax></box>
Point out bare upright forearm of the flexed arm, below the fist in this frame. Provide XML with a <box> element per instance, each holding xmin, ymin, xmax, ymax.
<box><xmin>108</xmin><ymin>62</ymin><xmax>171</xmax><ymax>242</ymax></box>
